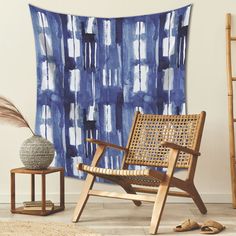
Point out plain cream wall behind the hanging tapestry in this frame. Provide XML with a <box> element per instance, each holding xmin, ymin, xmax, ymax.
<box><xmin>0</xmin><ymin>0</ymin><xmax>233</xmax><ymax>202</ymax></box>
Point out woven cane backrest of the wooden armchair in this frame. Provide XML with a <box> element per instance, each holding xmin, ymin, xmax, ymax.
<box><xmin>124</xmin><ymin>112</ymin><xmax>205</xmax><ymax>168</ymax></box>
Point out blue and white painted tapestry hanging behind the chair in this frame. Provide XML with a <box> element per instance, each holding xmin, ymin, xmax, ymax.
<box><xmin>30</xmin><ymin>6</ymin><xmax>191</xmax><ymax>181</ymax></box>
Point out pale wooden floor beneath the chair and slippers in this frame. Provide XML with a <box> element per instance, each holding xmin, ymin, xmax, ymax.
<box><xmin>0</xmin><ymin>201</ymin><xmax>236</xmax><ymax>236</ymax></box>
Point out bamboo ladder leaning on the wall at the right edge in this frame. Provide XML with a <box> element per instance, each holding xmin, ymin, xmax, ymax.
<box><xmin>226</xmin><ymin>14</ymin><xmax>236</xmax><ymax>208</ymax></box>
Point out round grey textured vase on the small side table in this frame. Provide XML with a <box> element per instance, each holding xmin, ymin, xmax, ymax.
<box><xmin>20</xmin><ymin>135</ymin><xmax>55</xmax><ymax>170</ymax></box>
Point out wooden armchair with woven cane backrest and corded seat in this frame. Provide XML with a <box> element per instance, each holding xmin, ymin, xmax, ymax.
<box><xmin>73</xmin><ymin>112</ymin><xmax>207</xmax><ymax>234</ymax></box>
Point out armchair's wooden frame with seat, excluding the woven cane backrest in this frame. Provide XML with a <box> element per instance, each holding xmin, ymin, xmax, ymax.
<box><xmin>73</xmin><ymin>112</ymin><xmax>207</xmax><ymax>234</ymax></box>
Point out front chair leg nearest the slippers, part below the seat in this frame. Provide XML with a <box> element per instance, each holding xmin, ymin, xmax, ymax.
<box><xmin>149</xmin><ymin>182</ymin><xmax>170</xmax><ymax>234</ymax></box>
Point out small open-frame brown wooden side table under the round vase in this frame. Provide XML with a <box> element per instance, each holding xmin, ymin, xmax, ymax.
<box><xmin>10</xmin><ymin>167</ymin><xmax>65</xmax><ymax>216</ymax></box>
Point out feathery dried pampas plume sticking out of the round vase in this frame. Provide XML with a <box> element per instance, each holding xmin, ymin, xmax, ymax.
<box><xmin>0</xmin><ymin>96</ymin><xmax>35</xmax><ymax>135</ymax></box>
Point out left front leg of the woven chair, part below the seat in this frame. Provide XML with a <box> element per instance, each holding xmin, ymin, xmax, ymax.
<box><xmin>72</xmin><ymin>174</ymin><xmax>95</xmax><ymax>223</ymax></box>
